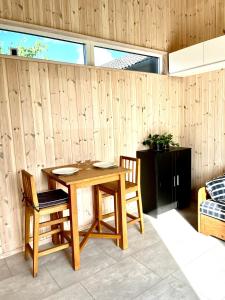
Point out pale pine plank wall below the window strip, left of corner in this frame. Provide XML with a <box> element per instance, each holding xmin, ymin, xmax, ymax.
<box><xmin>0</xmin><ymin>58</ymin><xmax>182</xmax><ymax>255</ymax></box>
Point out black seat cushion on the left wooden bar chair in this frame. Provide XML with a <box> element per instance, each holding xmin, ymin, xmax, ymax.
<box><xmin>37</xmin><ymin>189</ymin><xmax>68</xmax><ymax>208</ymax></box>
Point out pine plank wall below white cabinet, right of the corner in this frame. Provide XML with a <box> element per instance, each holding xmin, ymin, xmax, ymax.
<box><xmin>182</xmin><ymin>70</ymin><xmax>225</xmax><ymax>189</ymax></box>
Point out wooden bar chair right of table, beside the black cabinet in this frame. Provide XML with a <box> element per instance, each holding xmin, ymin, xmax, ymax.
<box><xmin>97</xmin><ymin>156</ymin><xmax>144</xmax><ymax>240</ymax></box>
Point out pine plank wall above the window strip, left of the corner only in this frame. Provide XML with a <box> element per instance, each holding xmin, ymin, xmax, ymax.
<box><xmin>0</xmin><ymin>0</ymin><xmax>170</xmax><ymax>50</ymax></box>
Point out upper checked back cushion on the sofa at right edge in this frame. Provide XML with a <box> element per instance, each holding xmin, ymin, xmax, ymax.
<box><xmin>206</xmin><ymin>176</ymin><xmax>225</xmax><ymax>203</ymax></box>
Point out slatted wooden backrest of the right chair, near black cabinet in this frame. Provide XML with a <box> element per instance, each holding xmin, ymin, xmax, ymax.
<box><xmin>120</xmin><ymin>156</ymin><xmax>141</xmax><ymax>184</ymax></box>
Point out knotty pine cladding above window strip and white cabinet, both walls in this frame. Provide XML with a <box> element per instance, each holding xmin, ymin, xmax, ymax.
<box><xmin>0</xmin><ymin>0</ymin><xmax>225</xmax><ymax>52</ymax></box>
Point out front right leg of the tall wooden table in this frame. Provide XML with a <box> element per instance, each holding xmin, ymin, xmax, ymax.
<box><xmin>118</xmin><ymin>174</ymin><xmax>128</xmax><ymax>250</ymax></box>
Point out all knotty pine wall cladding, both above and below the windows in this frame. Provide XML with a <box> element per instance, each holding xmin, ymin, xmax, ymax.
<box><xmin>0</xmin><ymin>0</ymin><xmax>225</xmax><ymax>255</ymax></box>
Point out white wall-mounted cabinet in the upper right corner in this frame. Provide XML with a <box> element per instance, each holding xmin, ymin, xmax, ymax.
<box><xmin>169</xmin><ymin>36</ymin><xmax>225</xmax><ymax>77</ymax></box>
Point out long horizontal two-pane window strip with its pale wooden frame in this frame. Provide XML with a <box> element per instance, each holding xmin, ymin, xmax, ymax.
<box><xmin>0</xmin><ymin>20</ymin><xmax>168</xmax><ymax>74</ymax></box>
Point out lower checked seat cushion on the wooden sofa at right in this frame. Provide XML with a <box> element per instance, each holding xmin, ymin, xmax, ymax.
<box><xmin>200</xmin><ymin>200</ymin><xmax>225</xmax><ymax>221</ymax></box>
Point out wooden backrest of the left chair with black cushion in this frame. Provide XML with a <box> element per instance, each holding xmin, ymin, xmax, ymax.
<box><xmin>21</xmin><ymin>170</ymin><xmax>39</xmax><ymax>207</ymax></box>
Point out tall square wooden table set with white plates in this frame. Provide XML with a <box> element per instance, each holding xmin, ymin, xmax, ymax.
<box><xmin>42</xmin><ymin>164</ymin><xmax>128</xmax><ymax>270</ymax></box>
